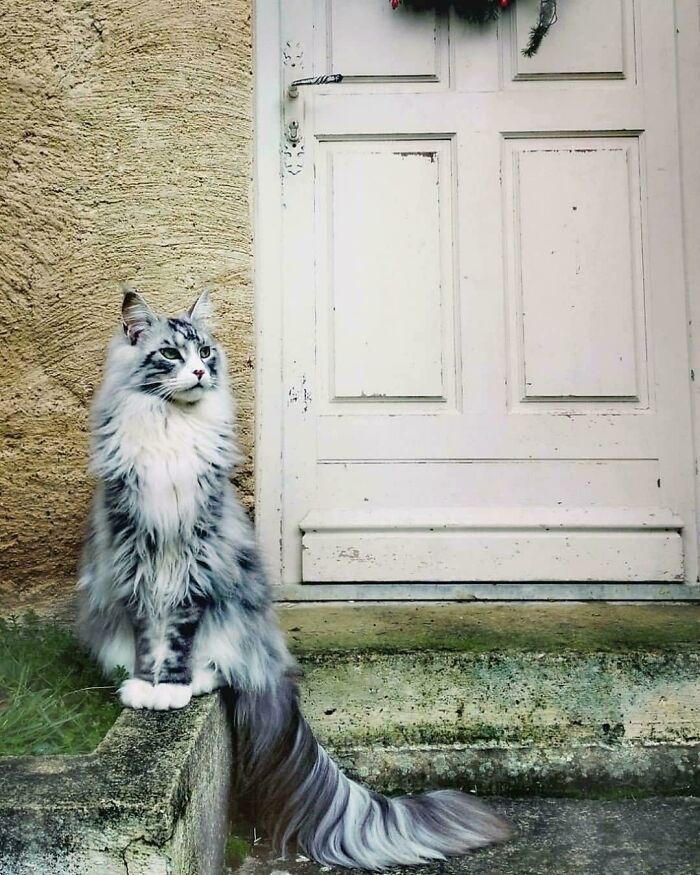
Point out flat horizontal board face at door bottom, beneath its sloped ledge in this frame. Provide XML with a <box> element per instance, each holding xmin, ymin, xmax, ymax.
<box><xmin>303</xmin><ymin>530</ymin><xmax>683</xmax><ymax>583</ymax></box>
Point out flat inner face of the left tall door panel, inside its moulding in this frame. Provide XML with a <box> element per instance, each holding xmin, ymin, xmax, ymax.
<box><xmin>326</xmin><ymin>141</ymin><xmax>451</xmax><ymax>400</ymax></box>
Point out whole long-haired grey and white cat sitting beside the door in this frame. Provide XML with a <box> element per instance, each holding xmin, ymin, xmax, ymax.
<box><xmin>80</xmin><ymin>291</ymin><xmax>506</xmax><ymax>870</ymax></box>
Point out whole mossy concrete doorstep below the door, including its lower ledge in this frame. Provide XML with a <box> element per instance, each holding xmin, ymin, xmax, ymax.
<box><xmin>280</xmin><ymin>603</ymin><xmax>700</xmax><ymax>796</ymax></box>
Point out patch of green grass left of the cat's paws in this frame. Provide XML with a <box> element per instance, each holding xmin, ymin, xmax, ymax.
<box><xmin>0</xmin><ymin>615</ymin><xmax>121</xmax><ymax>756</ymax></box>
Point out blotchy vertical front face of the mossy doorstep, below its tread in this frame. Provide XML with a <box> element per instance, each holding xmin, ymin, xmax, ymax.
<box><xmin>301</xmin><ymin>651</ymin><xmax>700</xmax><ymax>747</ymax></box>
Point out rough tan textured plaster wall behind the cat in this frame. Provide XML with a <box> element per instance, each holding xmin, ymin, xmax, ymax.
<box><xmin>0</xmin><ymin>0</ymin><xmax>253</xmax><ymax>610</ymax></box>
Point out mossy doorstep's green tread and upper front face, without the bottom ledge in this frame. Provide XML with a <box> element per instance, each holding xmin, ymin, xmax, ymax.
<box><xmin>281</xmin><ymin>604</ymin><xmax>700</xmax><ymax>768</ymax></box>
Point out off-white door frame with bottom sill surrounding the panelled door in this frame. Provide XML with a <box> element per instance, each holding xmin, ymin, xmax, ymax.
<box><xmin>253</xmin><ymin>0</ymin><xmax>700</xmax><ymax>601</ymax></box>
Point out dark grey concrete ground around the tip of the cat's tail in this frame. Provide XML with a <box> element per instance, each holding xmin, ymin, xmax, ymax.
<box><xmin>238</xmin><ymin>798</ymin><xmax>700</xmax><ymax>875</ymax></box>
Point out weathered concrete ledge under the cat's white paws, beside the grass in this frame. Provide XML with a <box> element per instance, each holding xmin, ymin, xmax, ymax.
<box><xmin>0</xmin><ymin>694</ymin><xmax>233</xmax><ymax>875</ymax></box>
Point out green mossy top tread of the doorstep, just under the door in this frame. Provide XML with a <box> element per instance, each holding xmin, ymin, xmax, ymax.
<box><xmin>279</xmin><ymin>604</ymin><xmax>700</xmax><ymax>658</ymax></box>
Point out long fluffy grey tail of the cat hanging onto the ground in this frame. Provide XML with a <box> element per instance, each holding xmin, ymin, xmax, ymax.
<box><xmin>234</xmin><ymin>679</ymin><xmax>508</xmax><ymax>870</ymax></box>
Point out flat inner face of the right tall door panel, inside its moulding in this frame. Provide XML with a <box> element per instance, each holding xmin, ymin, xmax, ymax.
<box><xmin>506</xmin><ymin>137</ymin><xmax>646</xmax><ymax>401</ymax></box>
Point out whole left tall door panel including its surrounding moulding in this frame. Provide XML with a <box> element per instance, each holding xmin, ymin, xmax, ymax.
<box><xmin>315</xmin><ymin>137</ymin><xmax>458</xmax><ymax>417</ymax></box>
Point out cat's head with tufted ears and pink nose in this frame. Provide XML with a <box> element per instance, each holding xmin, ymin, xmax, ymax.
<box><xmin>121</xmin><ymin>289</ymin><xmax>224</xmax><ymax>404</ymax></box>
